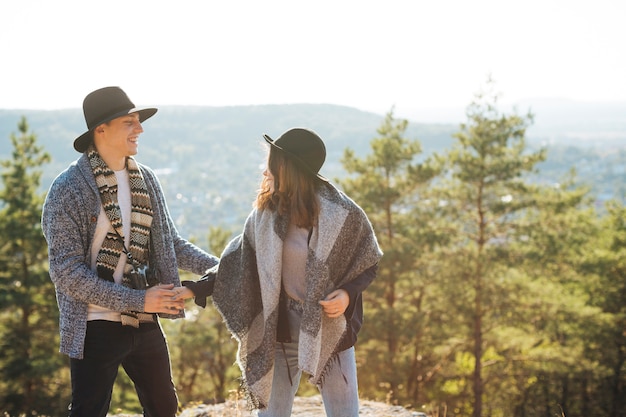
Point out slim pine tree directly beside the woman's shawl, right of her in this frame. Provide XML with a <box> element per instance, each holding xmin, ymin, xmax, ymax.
<box><xmin>338</xmin><ymin>111</ymin><xmax>436</xmax><ymax>401</ymax></box>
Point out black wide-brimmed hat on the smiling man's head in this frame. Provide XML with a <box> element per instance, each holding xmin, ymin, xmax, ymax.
<box><xmin>74</xmin><ymin>87</ymin><xmax>157</xmax><ymax>153</ymax></box>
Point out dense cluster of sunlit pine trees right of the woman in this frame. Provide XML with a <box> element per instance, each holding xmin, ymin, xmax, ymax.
<box><xmin>332</xmin><ymin>82</ymin><xmax>624</xmax><ymax>416</ymax></box>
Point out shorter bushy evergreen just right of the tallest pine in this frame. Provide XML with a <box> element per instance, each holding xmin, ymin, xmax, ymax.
<box><xmin>489</xmin><ymin>171</ymin><xmax>604</xmax><ymax>416</ymax></box>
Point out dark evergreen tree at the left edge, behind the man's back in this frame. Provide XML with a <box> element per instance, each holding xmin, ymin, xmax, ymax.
<box><xmin>0</xmin><ymin>117</ymin><xmax>69</xmax><ymax>416</ymax></box>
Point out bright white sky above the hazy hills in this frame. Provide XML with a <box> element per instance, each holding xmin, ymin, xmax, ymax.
<box><xmin>0</xmin><ymin>0</ymin><xmax>626</xmax><ymax>121</ymax></box>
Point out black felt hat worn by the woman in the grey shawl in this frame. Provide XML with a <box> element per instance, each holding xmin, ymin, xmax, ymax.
<box><xmin>263</xmin><ymin>127</ymin><xmax>328</xmax><ymax>181</ymax></box>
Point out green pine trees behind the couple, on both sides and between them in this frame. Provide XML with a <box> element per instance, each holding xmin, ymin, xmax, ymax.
<box><xmin>0</xmin><ymin>85</ymin><xmax>626</xmax><ymax>417</ymax></box>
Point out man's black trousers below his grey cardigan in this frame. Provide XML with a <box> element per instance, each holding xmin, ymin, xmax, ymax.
<box><xmin>70</xmin><ymin>320</ymin><xmax>178</xmax><ymax>417</ymax></box>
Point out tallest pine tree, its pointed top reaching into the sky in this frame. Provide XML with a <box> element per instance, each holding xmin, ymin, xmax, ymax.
<box><xmin>436</xmin><ymin>82</ymin><xmax>545</xmax><ymax>417</ymax></box>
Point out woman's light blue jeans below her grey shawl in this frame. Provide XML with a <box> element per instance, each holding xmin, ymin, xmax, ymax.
<box><xmin>258</xmin><ymin>302</ymin><xmax>359</xmax><ymax>417</ymax></box>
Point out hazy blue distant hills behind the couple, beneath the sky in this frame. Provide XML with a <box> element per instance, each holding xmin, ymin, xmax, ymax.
<box><xmin>0</xmin><ymin>102</ymin><xmax>626</xmax><ymax>239</ymax></box>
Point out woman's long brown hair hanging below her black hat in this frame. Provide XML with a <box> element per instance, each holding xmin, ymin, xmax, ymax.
<box><xmin>254</xmin><ymin>146</ymin><xmax>320</xmax><ymax>229</ymax></box>
